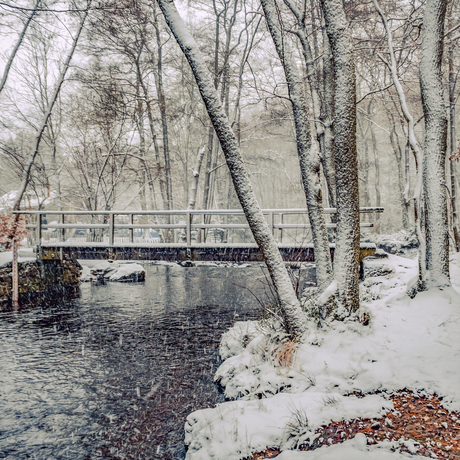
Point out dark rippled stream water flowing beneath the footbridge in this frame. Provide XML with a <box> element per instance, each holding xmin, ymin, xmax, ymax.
<box><xmin>0</xmin><ymin>265</ymin><xmax>280</xmax><ymax>460</ymax></box>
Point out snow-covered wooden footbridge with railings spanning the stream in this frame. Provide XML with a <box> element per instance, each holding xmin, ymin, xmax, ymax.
<box><xmin>19</xmin><ymin>207</ymin><xmax>383</xmax><ymax>262</ymax></box>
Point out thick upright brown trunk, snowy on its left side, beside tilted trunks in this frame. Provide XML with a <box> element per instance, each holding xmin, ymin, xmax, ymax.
<box><xmin>321</xmin><ymin>0</ymin><xmax>360</xmax><ymax>315</ymax></box>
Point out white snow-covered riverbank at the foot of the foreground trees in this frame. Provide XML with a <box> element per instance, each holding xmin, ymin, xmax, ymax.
<box><xmin>185</xmin><ymin>254</ymin><xmax>460</xmax><ymax>460</ymax></box>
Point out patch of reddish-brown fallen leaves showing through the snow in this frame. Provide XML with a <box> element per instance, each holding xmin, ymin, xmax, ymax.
<box><xmin>247</xmin><ymin>390</ymin><xmax>460</xmax><ymax>460</ymax></box>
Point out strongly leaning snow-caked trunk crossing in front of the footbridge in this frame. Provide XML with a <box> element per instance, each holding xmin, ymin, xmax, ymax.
<box><xmin>157</xmin><ymin>0</ymin><xmax>307</xmax><ymax>334</ymax></box>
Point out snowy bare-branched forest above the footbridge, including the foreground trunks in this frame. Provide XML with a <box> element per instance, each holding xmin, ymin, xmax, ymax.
<box><xmin>0</xmin><ymin>0</ymin><xmax>460</xmax><ymax>318</ymax></box>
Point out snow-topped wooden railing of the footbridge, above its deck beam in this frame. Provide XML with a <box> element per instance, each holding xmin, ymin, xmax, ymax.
<box><xmin>13</xmin><ymin>207</ymin><xmax>383</xmax><ymax>246</ymax></box>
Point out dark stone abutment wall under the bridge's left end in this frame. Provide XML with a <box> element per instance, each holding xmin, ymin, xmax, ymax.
<box><xmin>0</xmin><ymin>260</ymin><xmax>81</xmax><ymax>302</ymax></box>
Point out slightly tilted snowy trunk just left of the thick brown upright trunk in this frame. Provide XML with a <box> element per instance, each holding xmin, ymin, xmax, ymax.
<box><xmin>261</xmin><ymin>0</ymin><xmax>332</xmax><ymax>289</ymax></box>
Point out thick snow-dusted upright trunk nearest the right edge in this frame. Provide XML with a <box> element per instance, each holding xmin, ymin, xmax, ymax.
<box><xmin>420</xmin><ymin>0</ymin><xmax>450</xmax><ymax>287</ymax></box>
